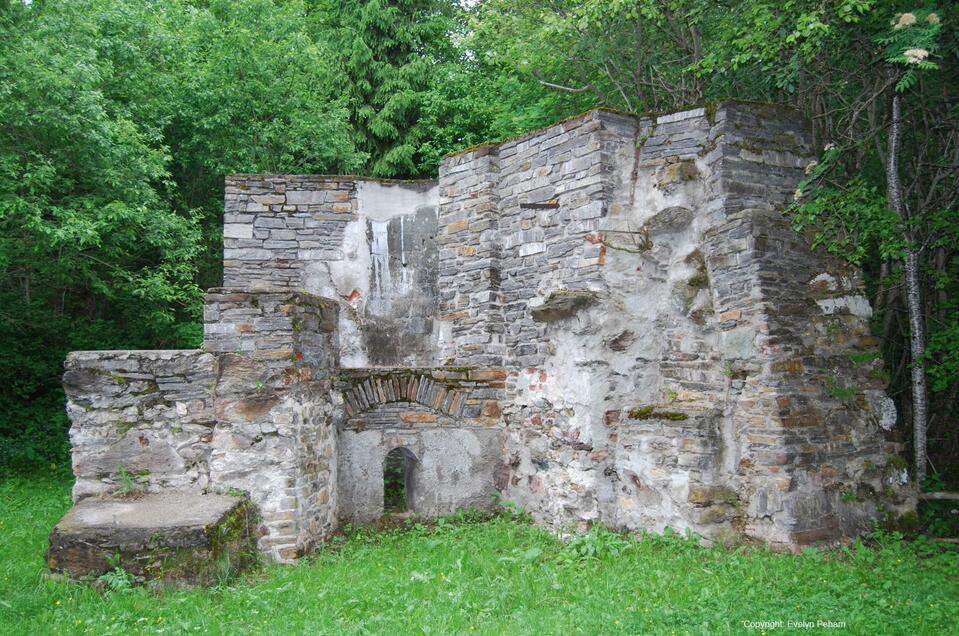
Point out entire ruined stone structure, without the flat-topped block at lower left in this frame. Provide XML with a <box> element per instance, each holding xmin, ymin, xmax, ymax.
<box><xmin>56</xmin><ymin>102</ymin><xmax>915</xmax><ymax>560</ymax></box>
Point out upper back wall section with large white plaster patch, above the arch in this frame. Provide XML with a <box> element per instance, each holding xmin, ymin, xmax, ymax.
<box><xmin>223</xmin><ymin>175</ymin><xmax>438</xmax><ymax>368</ymax></box>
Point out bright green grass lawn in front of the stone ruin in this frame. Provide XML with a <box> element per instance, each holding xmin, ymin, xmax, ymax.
<box><xmin>0</xmin><ymin>479</ymin><xmax>959</xmax><ymax>636</ymax></box>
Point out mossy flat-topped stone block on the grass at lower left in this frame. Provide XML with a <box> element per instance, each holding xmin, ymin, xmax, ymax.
<box><xmin>47</xmin><ymin>493</ymin><xmax>256</xmax><ymax>585</ymax></box>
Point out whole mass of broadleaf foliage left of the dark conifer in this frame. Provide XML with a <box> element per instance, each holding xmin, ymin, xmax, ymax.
<box><xmin>0</xmin><ymin>0</ymin><xmax>364</xmax><ymax>472</ymax></box>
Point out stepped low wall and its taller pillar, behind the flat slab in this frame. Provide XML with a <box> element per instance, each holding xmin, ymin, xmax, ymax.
<box><xmin>64</xmin><ymin>290</ymin><xmax>337</xmax><ymax>560</ymax></box>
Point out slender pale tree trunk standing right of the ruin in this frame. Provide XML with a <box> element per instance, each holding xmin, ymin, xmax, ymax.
<box><xmin>886</xmin><ymin>82</ymin><xmax>928</xmax><ymax>484</ymax></box>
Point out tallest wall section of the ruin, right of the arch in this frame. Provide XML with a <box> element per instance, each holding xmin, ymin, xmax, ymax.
<box><xmin>440</xmin><ymin>103</ymin><xmax>910</xmax><ymax>545</ymax></box>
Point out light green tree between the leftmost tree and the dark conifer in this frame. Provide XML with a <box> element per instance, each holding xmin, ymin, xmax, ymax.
<box><xmin>169</xmin><ymin>0</ymin><xmax>366</xmax><ymax>248</ymax></box>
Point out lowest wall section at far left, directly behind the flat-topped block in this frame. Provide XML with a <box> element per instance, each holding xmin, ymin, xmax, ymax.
<box><xmin>63</xmin><ymin>351</ymin><xmax>217</xmax><ymax>499</ymax></box>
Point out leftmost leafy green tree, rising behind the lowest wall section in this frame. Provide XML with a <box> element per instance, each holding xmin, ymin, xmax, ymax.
<box><xmin>0</xmin><ymin>1</ymin><xmax>201</xmax><ymax>471</ymax></box>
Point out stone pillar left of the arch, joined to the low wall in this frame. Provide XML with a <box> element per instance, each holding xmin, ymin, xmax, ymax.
<box><xmin>204</xmin><ymin>289</ymin><xmax>336</xmax><ymax>561</ymax></box>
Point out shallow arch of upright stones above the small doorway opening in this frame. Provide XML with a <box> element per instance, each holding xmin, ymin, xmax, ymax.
<box><xmin>343</xmin><ymin>373</ymin><xmax>470</xmax><ymax>417</ymax></box>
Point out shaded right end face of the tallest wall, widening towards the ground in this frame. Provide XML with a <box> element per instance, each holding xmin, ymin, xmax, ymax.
<box><xmin>705</xmin><ymin>102</ymin><xmax>910</xmax><ymax>546</ymax></box>
